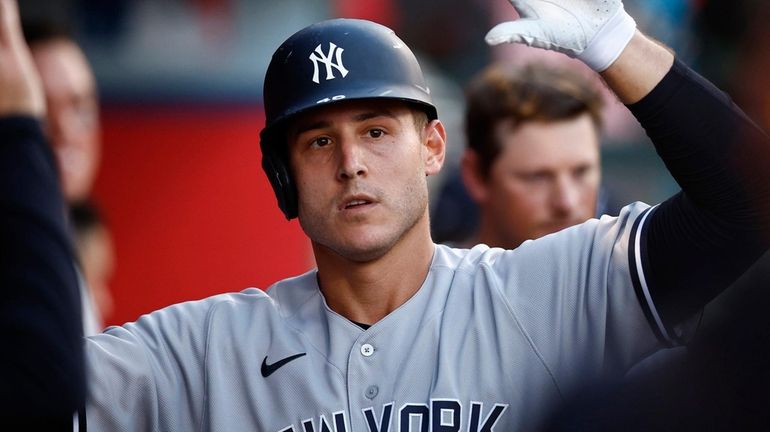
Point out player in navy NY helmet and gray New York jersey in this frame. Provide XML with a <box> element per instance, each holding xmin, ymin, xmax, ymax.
<box><xmin>1</xmin><ymin>0</ymin><xmax>770</xmax><ymax>432</ymax></box>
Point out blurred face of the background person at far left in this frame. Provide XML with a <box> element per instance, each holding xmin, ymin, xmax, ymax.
<box><xmin>32</xmin><ymin>40</ymin><xmax>100</xmax><ymax>201</ymax></box>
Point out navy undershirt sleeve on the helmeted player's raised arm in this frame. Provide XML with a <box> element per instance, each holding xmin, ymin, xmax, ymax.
<box><xmin>629</xmin><ymin>60</ymin><xmax>770</xmax><ymax>338</ymax></box>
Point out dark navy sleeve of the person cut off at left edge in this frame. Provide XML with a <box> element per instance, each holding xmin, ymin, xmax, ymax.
<box><xmin>0</xmin><ymin>117</ymin><xmax>85</xmax><ymax>430</ymax></box>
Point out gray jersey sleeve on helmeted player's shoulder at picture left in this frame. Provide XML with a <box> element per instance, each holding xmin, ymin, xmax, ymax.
<box><xmin>86</xmin><ymin>298</ymin><xmax>216</xmax><ymax>431</ymax></box>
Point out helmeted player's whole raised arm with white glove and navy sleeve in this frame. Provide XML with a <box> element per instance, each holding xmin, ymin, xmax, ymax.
<box><xmin>487</xmin><ymin>0</ymin><xmax>770</xmax><ymax>339</ymax></box>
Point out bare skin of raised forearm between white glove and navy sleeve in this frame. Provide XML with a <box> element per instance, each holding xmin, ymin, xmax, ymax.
<box><xmin>601</xmin><ymin>30</ymin><xmax>674</xmax><ymax>104</ymax></box>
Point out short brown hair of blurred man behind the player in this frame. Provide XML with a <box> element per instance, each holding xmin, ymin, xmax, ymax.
<box><xmin>465</xmin><ymin>63</ymin><xmax>603</xmax><ymax>178</ymax></box>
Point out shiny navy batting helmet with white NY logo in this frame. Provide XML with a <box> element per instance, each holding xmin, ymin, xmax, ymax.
<box><xmin>260</xmin><ymin>18</ymin><xmax>437</xmax><ymax>219</ymax></box>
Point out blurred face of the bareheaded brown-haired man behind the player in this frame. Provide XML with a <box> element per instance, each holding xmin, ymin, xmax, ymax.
<box><xmin>481</xmin><ymin>114</ymin><xmax>600</xmax><ymax>248</ymax></box>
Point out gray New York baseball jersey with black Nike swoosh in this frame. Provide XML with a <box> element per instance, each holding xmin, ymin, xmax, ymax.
<box><xmin>87</xmin><ymin>203</ymin><xmax>661</xmax><ymax>432</ymax></box>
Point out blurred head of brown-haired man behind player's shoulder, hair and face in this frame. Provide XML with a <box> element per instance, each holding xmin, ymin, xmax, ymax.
<box><xmin>462</xmin><ymin>63</ymin><xmax>603</xmax><ymax>249</ymax></box>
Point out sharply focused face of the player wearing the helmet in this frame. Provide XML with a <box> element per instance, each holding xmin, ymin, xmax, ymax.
<box><xmin>288</xmin><ymin>100</ymin><xmax>444</xmax><ymax>262</ymax></box>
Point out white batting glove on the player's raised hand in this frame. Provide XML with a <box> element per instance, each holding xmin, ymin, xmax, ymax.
<box><xmin>485</xmin><ymin>0</ymin><xmax>636</xmax><ymax>72</ymax></box>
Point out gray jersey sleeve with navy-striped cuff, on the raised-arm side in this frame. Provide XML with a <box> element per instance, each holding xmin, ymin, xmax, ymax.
<box><xmin>494</xmin><ymin>203</ymin><xmax>662</xmax><ymax>385</ymax></box>
